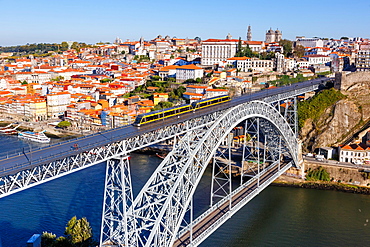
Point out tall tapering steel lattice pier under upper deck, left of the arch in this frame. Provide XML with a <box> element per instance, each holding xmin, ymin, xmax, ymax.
<box><xmin>100</xmin><ymin>152</ymin><xmax>136</xmax><ymax>246</ymax></box>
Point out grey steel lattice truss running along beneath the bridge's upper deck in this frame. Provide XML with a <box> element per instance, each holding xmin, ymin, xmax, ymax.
<box><xmin>0</xmin><ymin>85</ymin><xmax>319</xmax><ymax>198</ymax></box>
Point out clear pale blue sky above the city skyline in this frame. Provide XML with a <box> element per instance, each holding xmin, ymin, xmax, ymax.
<box><xmin>0</xmin><ymin>0</ymin><xmax>370</xmax><ymax>46</ymax></box>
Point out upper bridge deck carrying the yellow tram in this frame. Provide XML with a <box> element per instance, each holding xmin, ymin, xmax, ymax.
<box><xmin>0</xmin><ymin>78</ymin><xmax>330</xmax><ymax>176</ymax></box>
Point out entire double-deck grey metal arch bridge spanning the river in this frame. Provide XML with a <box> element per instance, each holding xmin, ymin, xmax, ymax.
<box><xmin>0</xmin><ymin>79</ymin><xmax>329</xmax><ymax>246</ymax></box>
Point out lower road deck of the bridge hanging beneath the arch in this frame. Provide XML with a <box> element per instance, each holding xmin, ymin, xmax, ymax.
<box><xmin>173</xmin><ymin>161</ymin><xmax>288</xmax><ymax>247</ymax></box>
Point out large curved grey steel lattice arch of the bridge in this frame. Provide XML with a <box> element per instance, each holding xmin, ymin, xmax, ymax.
<box><xmin>127</xmin><ymin>101</ymin><xmax>298</xmax><ymax>246</ymax></box>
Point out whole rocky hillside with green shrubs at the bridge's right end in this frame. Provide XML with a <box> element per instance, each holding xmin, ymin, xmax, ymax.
<box><xmin>298</xmin><ymin>72</ymin><xmax>370</xmax><ymax>151</ymax></box>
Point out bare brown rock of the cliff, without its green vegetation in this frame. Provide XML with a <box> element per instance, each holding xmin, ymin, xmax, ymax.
<box><xmin>300</xmin><ymin>72</ymin><xmax>370</xmax><ymax>151</ymax></box>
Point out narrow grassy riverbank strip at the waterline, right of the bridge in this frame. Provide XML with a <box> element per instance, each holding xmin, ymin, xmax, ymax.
<box><xmin>271</xmin><ymin>177</ymin><xmax>370</xmax><ymax>195</ymax></box>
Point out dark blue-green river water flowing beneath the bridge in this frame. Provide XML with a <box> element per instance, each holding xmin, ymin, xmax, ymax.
<box><xmin>0</xmin><ymin>136</ymin><xmax>370</xmax><ymax>247</ymax></box>
